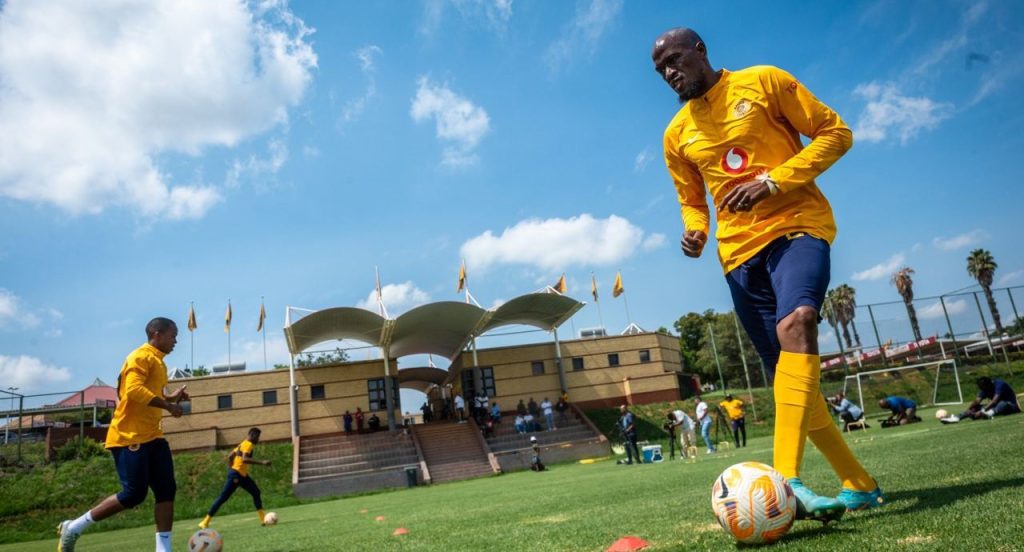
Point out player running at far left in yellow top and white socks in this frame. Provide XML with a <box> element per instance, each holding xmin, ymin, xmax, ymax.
<box><xmin>57</xmin><ymin>317</ymin><xmax>188</xmax><ymax>552</ymax></box>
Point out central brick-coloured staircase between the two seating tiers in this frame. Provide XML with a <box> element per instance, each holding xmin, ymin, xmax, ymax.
<box><xmin>413</xmin><ymin>422</ymin><xmax>496</xmax><ymax>483</ymax></box>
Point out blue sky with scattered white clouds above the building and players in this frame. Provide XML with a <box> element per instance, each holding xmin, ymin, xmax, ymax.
<box><xmin>0</xmin><ymin>0</ymin><xmax>1024</xmax><ymax>407</ymax></box>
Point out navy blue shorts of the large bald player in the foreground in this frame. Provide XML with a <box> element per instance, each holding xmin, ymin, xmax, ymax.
<box><xmin>725</xmin><ymin>233</ymin><xmax>831</xmax><ymax>379</ymax></box>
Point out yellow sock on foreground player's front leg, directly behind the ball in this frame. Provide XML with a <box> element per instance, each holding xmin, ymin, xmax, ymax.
<box><xmin>772</xmin><ymin>351</ymin><xmax>821</xmax><ymax>478</ymax></box>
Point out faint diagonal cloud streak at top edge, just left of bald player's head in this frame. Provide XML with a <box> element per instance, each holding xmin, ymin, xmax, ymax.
<box><xmin>544</xmin><ymin>0</ymin><xmax>623</xmax><ymax>72</ymax></box>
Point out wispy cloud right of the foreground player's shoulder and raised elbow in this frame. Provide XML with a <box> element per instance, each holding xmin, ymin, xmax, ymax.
<box><xmin>853</xmin><ymin>82</ymin><xmax>953</xmax><ymax>144</ymax></box>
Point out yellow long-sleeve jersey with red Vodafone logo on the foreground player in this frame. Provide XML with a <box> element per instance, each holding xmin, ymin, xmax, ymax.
<box><xmin>665</xmin><ymin>66</ymin><xmax>853</xmax><ymax>273</ymax></box>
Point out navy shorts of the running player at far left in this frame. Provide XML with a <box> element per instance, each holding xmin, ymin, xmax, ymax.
<box><xmin>111</xmin><ymin>439</ymin><xmax>177</xmax><ymax>508</ymax></box>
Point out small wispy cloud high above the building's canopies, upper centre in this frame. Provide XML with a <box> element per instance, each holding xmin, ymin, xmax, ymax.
<box><xmin>410</xmin><ymin>77</ymin><xmax>490</xmax><ymax>167</ymax></box>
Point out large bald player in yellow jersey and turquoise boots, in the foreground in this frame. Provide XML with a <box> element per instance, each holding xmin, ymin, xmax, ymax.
<box><xmin>651</xmin><ymin>29</ymin><xmax>886</xmax><ymax>522</ymax></box>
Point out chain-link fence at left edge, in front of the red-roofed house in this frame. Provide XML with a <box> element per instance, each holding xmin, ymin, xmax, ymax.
<box><xmin>0</xmin><ymin>389</ymin><xmax>114</xmax><ymax>467</ymax></box>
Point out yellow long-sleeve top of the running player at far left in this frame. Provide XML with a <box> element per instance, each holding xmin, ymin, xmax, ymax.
<box><xmin>106</xmin><ymin>343</ymin><xmax>167</xmax><ymax>449</ymax></box>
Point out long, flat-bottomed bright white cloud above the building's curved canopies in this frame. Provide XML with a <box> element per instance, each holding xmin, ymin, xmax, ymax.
<box><xmin>461</xmin><ymin>213</ymin><xmax>666</xmax><ymax>271</ymax></box>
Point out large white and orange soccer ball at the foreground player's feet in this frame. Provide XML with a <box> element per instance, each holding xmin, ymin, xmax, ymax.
<box><xmin>711</xmin><ymin>462</ymin><xmax>797</xmax><ymax>544</ymax></box>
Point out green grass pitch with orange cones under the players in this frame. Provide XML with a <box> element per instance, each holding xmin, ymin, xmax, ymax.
<box><xmin>0</xmin><ymin>403</ymin><xmax>1024</xmax><ymax>552</ymax></box>
